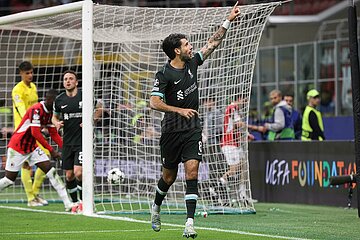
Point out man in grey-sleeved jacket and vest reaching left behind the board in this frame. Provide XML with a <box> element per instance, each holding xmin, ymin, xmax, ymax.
<box><xmin>248</xmin><ymin>90</ymin><xmax>295</xmax><ymax>141</ymax></box>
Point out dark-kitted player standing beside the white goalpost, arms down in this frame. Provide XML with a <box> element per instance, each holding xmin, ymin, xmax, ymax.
<box><xmin>52</xmin><ymin>70</ymin><xmax>82</xmax><ymax>213</ymax></box>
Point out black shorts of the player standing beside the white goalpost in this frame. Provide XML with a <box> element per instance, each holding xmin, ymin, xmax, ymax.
<box><xmin>62</xmin><ymin>146</ymin><xmax>82</xmax><ymax>170</ymax></box>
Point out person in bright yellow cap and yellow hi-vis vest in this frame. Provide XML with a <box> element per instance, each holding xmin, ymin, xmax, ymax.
<box><xmin>301</xmin><ymin>89</ymin><xmax>325</xmax><ymax>141</ymax></box>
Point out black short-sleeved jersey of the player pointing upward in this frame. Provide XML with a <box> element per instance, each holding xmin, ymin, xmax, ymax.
<box><xmin>151</xmin><ymin>52</ymin><xmax>203</xmax><ymax>133</ymax></box>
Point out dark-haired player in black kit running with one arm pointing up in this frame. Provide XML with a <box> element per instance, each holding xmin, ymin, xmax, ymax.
<box><xmin>150</xmin><ymin>3</ymin><xmax>240</xmax><ymax>238</ymax></box>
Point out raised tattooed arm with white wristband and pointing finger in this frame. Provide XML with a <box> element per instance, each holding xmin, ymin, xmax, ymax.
<box><xmin>200</xmin><ymin>2</ymin><xmax>240</xmax><ymax>60</ymax></box>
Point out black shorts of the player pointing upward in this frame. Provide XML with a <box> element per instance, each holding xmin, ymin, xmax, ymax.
<box><xmin>160</xmin><ymin>129</ymin><xmax>202</xmax><ymax>169</ymax></box>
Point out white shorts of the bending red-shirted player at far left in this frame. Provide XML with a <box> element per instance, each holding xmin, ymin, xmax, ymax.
<box><xmin>5</xmin><ymin>147</ymin><xmax>49</xmax><ymax>172</ymax></box>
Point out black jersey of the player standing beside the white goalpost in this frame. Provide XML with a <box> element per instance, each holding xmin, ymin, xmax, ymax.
<box><xmin>54</xmin><ymin>90</ymin><xmax>82</xmax><ymax>146</ymax></box>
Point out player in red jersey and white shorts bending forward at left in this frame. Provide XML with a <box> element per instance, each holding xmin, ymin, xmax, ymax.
<box><xmin>0</xmin><ymin>90</ymin><xmax>73</xmax><ymax>211</ymax></box>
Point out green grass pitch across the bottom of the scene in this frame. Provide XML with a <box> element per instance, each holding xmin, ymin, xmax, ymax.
<box><xmin>0</xmin><ymin>203</ymin><xmax>360</xmax><ymax>240</ymax></box>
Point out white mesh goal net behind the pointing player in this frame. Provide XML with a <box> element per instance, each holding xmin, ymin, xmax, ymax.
<box><xmin>0</xmin><ymin>2</ymin><xmax>280</xmax><ymax>216</ymax></box>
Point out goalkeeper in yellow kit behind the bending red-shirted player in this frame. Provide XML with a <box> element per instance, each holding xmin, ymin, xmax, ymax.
<box><xmin>12</xmin><ymin>61</ymin><xmax>49</xmax><ymax>207</ymax></box>
